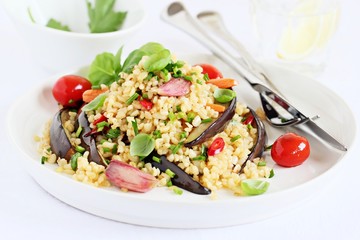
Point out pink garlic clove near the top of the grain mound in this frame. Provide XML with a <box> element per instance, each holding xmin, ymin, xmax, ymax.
<box><xmin>158</xmin><ymin>78</ymin><xmax>191</xmax><ymax>97</ymax></box>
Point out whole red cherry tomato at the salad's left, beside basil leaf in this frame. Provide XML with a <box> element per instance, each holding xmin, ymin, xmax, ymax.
<box><xmin>52</xmin><ymin>75</ymin><xmax>91</xmax><ymax>107</ymax></box>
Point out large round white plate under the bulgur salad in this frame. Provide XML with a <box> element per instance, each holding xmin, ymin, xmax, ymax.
<box><xmin>7</xmin><ymin>55</ymin><xmax>356</xmax><ymax>228</ymax></box>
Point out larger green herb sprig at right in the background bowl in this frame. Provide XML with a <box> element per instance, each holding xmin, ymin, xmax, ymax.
<box><xmin>87</xmin><ymin>0</ymin><xmax>127</xmax><ymax>33</ymax></box>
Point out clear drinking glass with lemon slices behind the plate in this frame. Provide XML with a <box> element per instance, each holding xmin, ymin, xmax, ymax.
<box><xmin>252</xmin><ymin>0</ymin><xmax>340</xmax><ymax>76</ymax></box>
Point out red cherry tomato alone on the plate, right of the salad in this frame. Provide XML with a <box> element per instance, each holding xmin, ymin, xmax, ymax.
<box><xmin>271</xmin><ymin>133</ymin><xmax>310</xmax><ymax>167</ymax></box>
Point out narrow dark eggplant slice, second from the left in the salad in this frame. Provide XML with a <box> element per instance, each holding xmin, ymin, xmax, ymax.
<box><xmin>76</xmin><ymin>111</ymin><xmax>107</xmax><ymax>166</ymax></box>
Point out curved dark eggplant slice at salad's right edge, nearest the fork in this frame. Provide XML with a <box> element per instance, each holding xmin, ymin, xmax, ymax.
<box><xmin>244</xmin><ymin>108</ymin><xmax>267</xmax><ymax>164</ymax></box>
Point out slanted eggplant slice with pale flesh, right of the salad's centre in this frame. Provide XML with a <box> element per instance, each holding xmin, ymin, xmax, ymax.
<box><xmin>184</xmin><ymin>97</ymin><xmax>237</xmax><ymax>147</ymax></box>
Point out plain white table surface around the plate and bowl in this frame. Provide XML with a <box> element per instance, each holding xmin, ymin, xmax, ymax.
<box><xmin>0</xmin><ymin>0</ymin><xmax>360</xmax><ymax>240</ymax></box>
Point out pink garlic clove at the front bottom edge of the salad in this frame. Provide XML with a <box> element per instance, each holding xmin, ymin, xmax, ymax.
<box><xmin>105</xmin><ymin>160</ymin><xmax>157</xmax><ymax>192</ymax></box>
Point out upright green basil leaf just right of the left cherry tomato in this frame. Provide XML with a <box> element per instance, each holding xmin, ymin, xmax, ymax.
<box><xmin>88</xmin><ymin>52</ymin><xmax>120</xmax><ymax>88</ymax></box>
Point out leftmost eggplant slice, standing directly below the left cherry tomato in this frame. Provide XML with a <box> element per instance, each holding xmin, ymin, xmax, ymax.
<box><xmin>50</xmin><ymin>108</ymin><xmax>76</xmax><ymax>160</ymax></box>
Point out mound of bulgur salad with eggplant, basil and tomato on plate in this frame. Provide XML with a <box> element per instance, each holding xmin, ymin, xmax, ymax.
<box><xmin>37</xmin><ymin>42</ymin><xmax>274</xmax><ymax>198</ymax></box>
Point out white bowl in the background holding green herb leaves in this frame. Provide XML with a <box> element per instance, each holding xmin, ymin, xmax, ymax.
<box><xmin>2</xmin><ymin>0</ymin><xmax>146</xmax><ymax>71</ymax></box>
